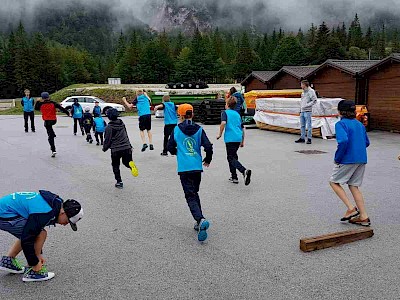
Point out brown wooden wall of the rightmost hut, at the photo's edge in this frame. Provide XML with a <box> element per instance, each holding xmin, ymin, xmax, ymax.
<box><xmin>367</xmin><ymin>62</ymin><xmax>400</xmax><ymax>132</ymax></box>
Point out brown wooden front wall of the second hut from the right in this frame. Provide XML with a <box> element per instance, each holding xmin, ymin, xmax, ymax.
<box><xmin>309</xmin><ymin>67</ymin><xmax>356</xmax><ymax>101</ymax></box>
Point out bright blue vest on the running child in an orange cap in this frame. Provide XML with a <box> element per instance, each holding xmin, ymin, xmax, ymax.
<box><xmin>174</xmin><ymin>126</ymin><xmax>203</xmax><ymax>173</ymax></box>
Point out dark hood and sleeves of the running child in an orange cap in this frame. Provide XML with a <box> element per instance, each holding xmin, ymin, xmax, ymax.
<box><xmin>168</xmin><ymin>120</ymin><xmax>213</xmax><ymax>164</ymax></box>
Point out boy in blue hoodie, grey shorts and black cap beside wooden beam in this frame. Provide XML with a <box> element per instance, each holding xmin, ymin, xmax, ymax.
<box><xmin>330</xmin><ymin>100</ymin><xmax>371</xmax><ymax>226</ymax></box>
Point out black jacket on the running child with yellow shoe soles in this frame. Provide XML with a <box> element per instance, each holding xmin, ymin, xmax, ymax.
<box><xmin>103</xmin><ymin>119</ymin><xmax>132</xmax><ymax>152</ymax></box>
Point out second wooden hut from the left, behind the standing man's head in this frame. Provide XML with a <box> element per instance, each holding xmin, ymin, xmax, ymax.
<box><xmin>270</xmin><ymin>66</ymin><xmax>319</xmax><ymax>90</ymax></box>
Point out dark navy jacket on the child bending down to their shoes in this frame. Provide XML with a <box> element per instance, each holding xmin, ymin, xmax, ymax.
<box><xmin>21</xmin><ymin>190</ymin><xmax>62</xmax><ymax>267</ymax></box>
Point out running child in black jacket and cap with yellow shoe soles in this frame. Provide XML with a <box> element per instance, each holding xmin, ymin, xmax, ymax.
<box><xmin>103</xmin><ymin>108</ymin><xmax>139</xmax><ymax>189</ymax></box>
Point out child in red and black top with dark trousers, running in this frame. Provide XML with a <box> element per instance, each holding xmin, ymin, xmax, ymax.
<box><xmin>35</xmin><ymin>92</ymin><xmax>70</xmax><ymax>157</ymax></box>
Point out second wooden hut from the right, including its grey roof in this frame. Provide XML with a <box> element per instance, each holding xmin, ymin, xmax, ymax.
<box><xmin>306</xmin><ymin>60</ymin><xmax>379</xmax><ymax>104</ymax></box>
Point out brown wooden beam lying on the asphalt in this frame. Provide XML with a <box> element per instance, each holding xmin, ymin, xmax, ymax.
<box><xmin>300</xmin><ymin>228</ymin><xmax>374</xmax><ymax>252</ymax></box>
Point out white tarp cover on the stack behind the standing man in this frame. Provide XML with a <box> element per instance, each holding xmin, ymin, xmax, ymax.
<box><xmin>254</xmin><ymin>98</ymin><xmax>343</xmax><ymax>139</ymax></box>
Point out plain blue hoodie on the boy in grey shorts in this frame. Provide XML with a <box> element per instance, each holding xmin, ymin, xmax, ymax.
<box><xmin>335</xmin><ymin>118</ymin><xmax>370</xmax><ymax>165</ymax></box>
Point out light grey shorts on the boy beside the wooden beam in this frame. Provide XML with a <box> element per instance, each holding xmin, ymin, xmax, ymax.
<box><xmin>330</xmin><ymin>164</ymin><xmax>365</xmax><ymax>187</ymax></box>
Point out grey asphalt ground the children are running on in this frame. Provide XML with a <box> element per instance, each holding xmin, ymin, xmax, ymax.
<box><xmin>0</xmin><ymin>116</ymin><xmax>400</xmax><ymax>299</ymax></box>
